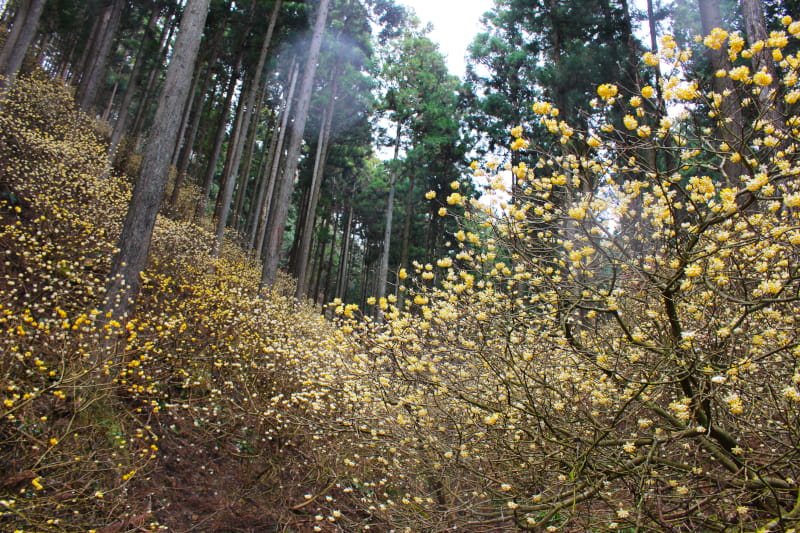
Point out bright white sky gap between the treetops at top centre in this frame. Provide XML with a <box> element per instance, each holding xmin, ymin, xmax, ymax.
<box><xmin>398</xmin><ymin>0</ymin><xmax>494</xmax><ymax>78</ymax></box>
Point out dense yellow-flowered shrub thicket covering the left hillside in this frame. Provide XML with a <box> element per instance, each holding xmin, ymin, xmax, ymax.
<box><xmin>0</xmin><ymin>76</ymin><xmax>348</xmax><ymax>532</ymax></box>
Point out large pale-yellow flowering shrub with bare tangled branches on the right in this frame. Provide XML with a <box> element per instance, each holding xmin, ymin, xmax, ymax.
<box><xmin>324</xmin><ymin>20</ymin><xmax>800</xmax><ymax>531</ymax></box>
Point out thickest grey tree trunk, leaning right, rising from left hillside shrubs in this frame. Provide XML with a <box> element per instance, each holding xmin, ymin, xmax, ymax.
<box><xmin>104</xmin><ymin>0</ymin><xmax>210</xmax><ymax>324</ymax></box>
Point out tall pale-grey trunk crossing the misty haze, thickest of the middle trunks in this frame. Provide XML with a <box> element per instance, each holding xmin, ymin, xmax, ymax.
<box><xmin>261</xmin><ymin>0</ymin><xmax>330</xmax><ymax>286</ymax></box>
